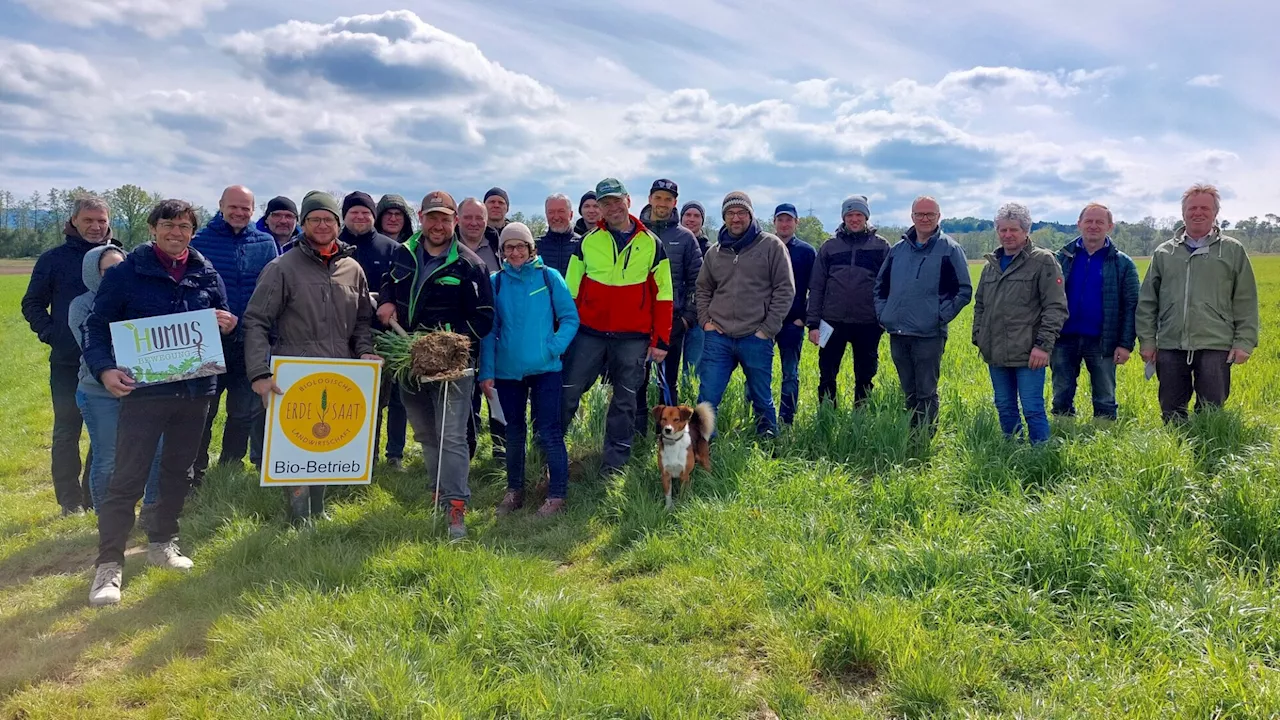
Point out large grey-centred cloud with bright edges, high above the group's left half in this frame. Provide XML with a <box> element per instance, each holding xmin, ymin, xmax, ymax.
<box><xmin>220</xmin><ymin>10</ymin><xmax>558</xmax><ymax>111</ymax></box>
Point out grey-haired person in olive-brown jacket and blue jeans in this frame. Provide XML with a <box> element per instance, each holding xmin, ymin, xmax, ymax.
<box><xmin>973</xmin><ymin>202</ymin><xmax>1066</xmax><ymax>445</ymax></box>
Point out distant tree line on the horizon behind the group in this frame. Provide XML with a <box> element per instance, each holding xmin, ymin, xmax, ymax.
<box><xmin>0</xmin><ymin>184</ymin><xmax>1280</xmax><ymax>260</ymax></box>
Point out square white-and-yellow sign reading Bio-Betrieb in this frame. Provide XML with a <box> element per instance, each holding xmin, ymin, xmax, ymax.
<box><xmin>261</xmin><ymin>357</ymin><xmax>383</xmax><ymax>487</ymax></box>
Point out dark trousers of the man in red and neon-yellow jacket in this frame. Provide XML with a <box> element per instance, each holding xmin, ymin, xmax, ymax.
<box><xmin>561</xmin><ymin>332</ymin><xmax>649</xmax><ymax>471</ymax></box>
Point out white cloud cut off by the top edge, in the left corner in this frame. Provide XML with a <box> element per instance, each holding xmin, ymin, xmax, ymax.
<box><xmin>18</xmin><ymin>0</ymin><xmax>227</xmax><ymax>37</ymax></box>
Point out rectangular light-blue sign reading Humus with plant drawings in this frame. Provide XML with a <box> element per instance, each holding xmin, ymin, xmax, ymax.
<box><xmin>110</xmin><ymin>310</ymin><xmax>227</xmax><ymax>386</ymax></box>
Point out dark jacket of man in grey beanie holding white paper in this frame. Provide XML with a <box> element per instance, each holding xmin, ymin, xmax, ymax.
<box><xmin>805</xmin><ymin>223</ymin><xmax>888</xmax><ymax>329</ymax></box>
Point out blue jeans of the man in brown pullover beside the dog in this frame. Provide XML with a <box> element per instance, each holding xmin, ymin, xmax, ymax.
<box><xmin>698</xmin><ymin>332</ymin><xmax>778</xmax><ymax>436</ymax></box>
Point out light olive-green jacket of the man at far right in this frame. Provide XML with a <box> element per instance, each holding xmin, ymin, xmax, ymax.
<box><xmin>1137</xmin><ymin>228</ymin><xmax>1261</xmax><ymax>352</ymax></box>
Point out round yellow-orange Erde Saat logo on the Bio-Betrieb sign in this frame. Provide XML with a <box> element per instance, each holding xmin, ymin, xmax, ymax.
<box><xmin>280</xmin><ymin>373</ymin><xmax>366</xmax><ymax>452</ymax></box>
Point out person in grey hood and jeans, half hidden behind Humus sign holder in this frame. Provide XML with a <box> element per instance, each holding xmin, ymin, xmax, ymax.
<box><xmin>67</xmin><ymin>245</ymin><xmax>164</xmax><ymax>530</ymax></box>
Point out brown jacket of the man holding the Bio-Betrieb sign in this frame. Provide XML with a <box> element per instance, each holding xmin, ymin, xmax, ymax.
<box><xmin>244</xmin><ymin>240</ymin><xmax>374</xmax><ymax>380</ymax></box>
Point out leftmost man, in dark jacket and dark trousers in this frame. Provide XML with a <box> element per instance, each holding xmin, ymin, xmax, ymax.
<box><xmin>22</xmin><ymin>196</ymin><xmax>120</xmax><ymax>515</ymax></box>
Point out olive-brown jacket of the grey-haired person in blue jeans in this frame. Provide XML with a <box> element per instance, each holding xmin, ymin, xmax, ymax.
<box><xmin>973</xmin><ymin>243</ymin><xmax>1066</xmax><ymax>368</ymax></box>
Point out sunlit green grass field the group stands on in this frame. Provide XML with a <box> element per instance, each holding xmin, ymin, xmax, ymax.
<box><xmin>0</xmin><ymin>258</ymin><xmax>1280</xmax><ymax>720</ymax></box>
